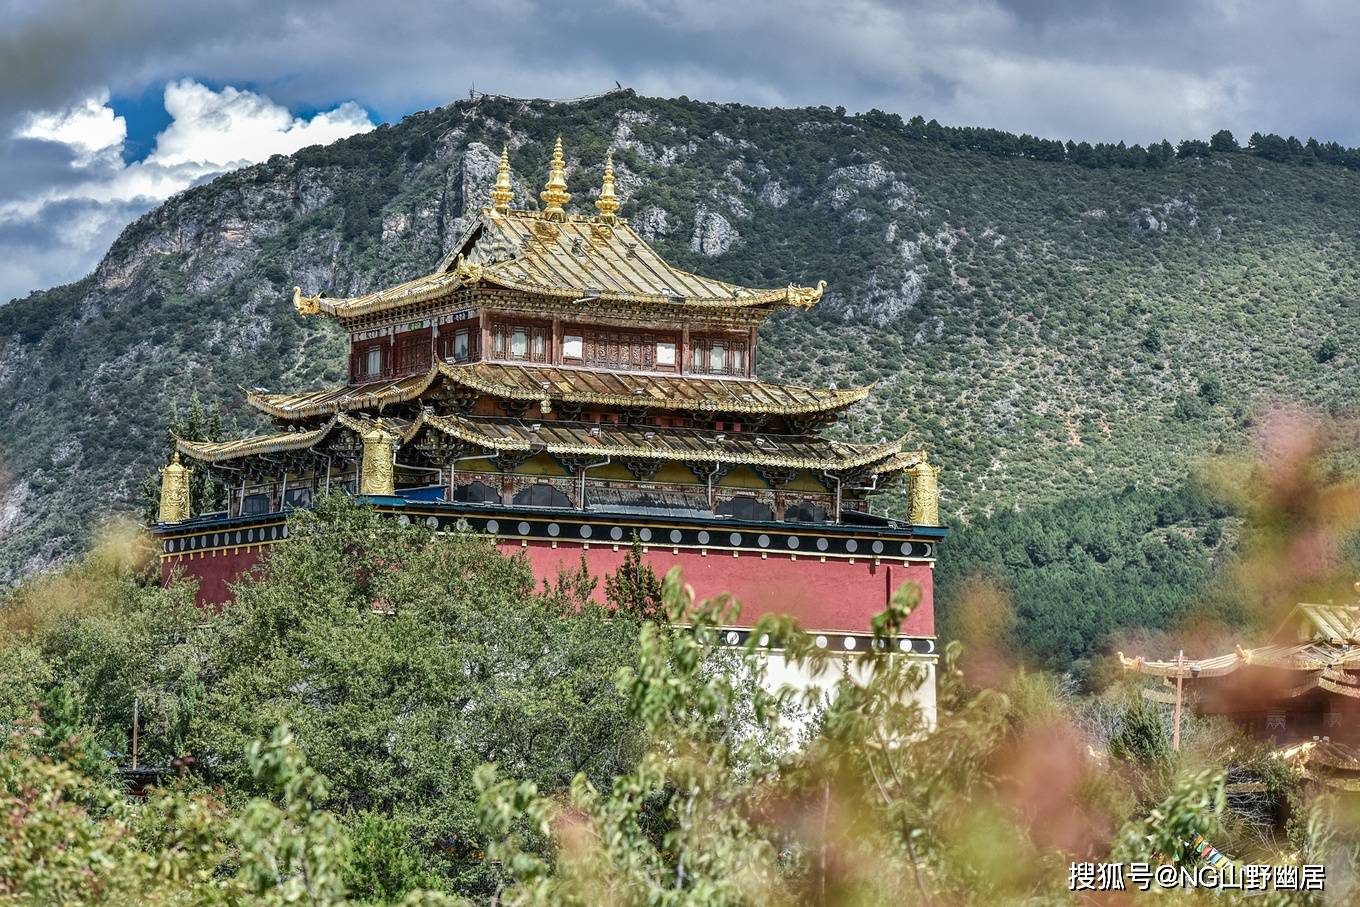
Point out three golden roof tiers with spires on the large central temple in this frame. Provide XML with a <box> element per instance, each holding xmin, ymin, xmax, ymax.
<box><xmin>177</xmin><ymin>140</ymin><xmax>922</xmax><ymax>497</ymax></box>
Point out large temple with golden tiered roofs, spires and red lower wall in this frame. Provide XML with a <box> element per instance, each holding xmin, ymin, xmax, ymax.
<box><xmin>155</xmin><ymin>139</ymin><xmax>945</xmax><ymax>688</ymax></box>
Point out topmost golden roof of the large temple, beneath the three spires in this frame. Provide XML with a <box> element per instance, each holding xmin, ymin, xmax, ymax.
<box><xmin>295</xmin><ymin>208</ymin><xmax>826</xmax><ymax>318</ymax></box>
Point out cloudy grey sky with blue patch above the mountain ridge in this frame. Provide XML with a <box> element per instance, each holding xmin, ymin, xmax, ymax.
<box><xmin>0</xmin><ymin>0</ymin><xmax>1360</xmax><ymax>303</ymax></box>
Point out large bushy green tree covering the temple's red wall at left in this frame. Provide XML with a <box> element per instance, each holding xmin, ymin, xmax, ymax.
<box><xmin>190</xmin><ymin>495</ymin><xmax>641</xmax><ymax>892</ymax></box>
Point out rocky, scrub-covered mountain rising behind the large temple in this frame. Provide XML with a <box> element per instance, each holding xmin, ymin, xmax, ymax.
<box><xmin>0</xmin><ymin>91</ymin><xmax>1360</xmax><ymax>660</ymax></box>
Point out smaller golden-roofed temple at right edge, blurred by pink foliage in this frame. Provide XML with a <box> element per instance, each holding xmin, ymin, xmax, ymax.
<box><xmin>1119</xmin><ymin>592</ymin><xmax>1360</xmax><ymax>790</ymax></box>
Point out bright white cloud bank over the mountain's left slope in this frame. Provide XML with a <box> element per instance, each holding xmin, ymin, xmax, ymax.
<box><xmin>0</xmin><ymin>79</ymin><xmax>374</xmax><ymax>305</ymax></box>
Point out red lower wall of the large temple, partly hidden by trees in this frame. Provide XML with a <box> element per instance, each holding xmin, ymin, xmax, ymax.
<box><xmin>160</xmin><ymin>540</ymin><xmax>934</xmax><ymax>636</ymax></box>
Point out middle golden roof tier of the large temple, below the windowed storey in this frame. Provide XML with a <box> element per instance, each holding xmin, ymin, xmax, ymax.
<box><xmin>246</xmin><ymin>362</ymin><xmax>872</xmax><ymax>419</ymax></box>
